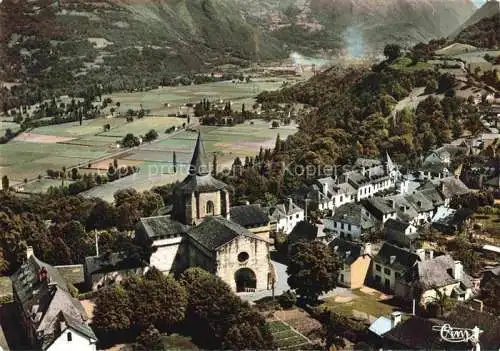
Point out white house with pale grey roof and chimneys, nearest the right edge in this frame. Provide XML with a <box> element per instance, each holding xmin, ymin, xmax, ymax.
<box><xmin>394</xmin><ymin>251</ymin><xmax>475</xmax><ymax>305</ymax></box>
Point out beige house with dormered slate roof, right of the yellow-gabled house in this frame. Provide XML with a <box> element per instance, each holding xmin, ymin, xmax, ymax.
<box><xmin>372</xmin><ymin>242</ymin><xmax>420</xmax><ymax>291</ymax></box>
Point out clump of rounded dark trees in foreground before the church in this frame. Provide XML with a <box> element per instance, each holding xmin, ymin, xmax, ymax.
<box><xmin>92</xmin><ymin>268</ymin><xmax>273</xmax><ymax>350</ymax></box>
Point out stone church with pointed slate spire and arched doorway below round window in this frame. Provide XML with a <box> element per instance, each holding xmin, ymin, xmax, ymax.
<box><xmin>136</xmin><ymin>133</ymin><xmax>275</xmax><ymax>292</ymax></box>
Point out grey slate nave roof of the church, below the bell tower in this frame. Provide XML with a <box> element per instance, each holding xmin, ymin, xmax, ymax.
<box><xmin>187</xmin><ymin>217</ymin><xmax>265</xmax><ymax>251</ymax></box>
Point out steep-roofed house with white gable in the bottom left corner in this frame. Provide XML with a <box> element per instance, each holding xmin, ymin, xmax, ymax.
<box><xmin>11</xmin><ymin>247</ymin><xmax>97</xmax><ymax>351</ymax></box>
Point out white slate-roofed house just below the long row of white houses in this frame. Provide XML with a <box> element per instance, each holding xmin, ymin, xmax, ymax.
<box><xmin>325</xmin><ymin>203</ymin><xmax>377</xmax><ymax>240</ymax></box>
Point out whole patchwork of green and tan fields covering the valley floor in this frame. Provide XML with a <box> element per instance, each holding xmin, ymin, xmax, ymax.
<box><xmin>0</xmin><ymin>78</ymin><xmax>296</xmax><ymax>199</ymax></box>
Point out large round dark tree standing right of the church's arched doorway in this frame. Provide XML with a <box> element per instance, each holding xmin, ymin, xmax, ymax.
<box><xmin>287</xmin><ymin>241</ymin><xmax>341</xmax><ymax>302</ymax></box>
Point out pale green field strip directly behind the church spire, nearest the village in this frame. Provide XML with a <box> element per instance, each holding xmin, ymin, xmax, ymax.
<box><xmin>79</xmin><ymin>120</ymin><xmax>296</xmax><ymax>201</ymax></box>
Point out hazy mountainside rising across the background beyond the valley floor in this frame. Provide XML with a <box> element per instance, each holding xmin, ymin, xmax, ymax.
<box><xmin>0</xmin><ymin>0</ymin><xmax>474</xmax><ymax>95</ymax></box>
